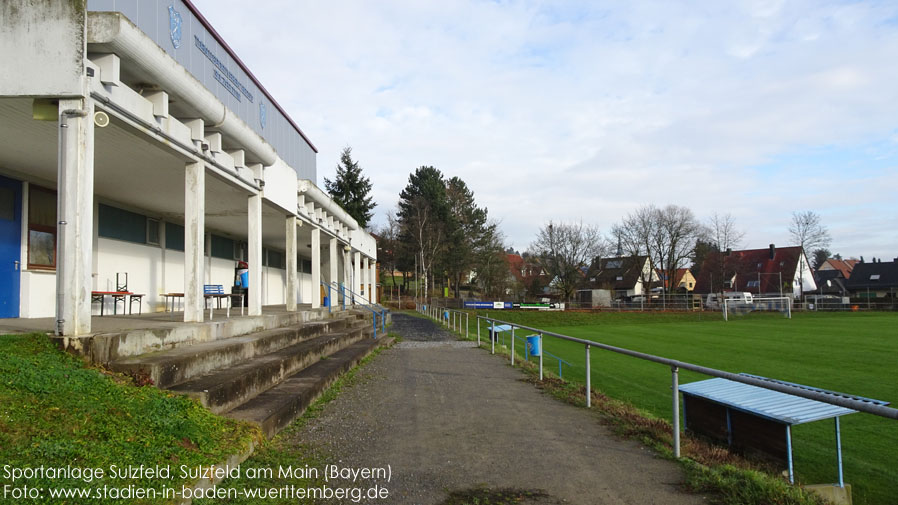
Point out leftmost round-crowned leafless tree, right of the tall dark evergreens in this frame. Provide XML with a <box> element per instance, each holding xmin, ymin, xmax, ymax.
<box><xmin>530</xmin><ymin>221</ymin><xmax>606</xmax><ymax>301</ymax></box>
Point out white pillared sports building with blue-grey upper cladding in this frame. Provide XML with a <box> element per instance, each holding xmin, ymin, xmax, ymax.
<box><xmin>0</xmin><ymin>0</ymin><xmax>376</xmax><ymax>335</ymax></box>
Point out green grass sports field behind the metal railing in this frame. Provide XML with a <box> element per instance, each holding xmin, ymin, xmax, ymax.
<box><xmin>471</xmin><ymin>311</ymin><xmax>898</xmax><ymax>504</ymax></box>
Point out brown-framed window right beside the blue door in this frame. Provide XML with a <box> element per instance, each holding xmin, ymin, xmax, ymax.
<box><xmin>28</xmin><ymin>184</ymin><xmax>56</xmax><ymax>270</ymax></box>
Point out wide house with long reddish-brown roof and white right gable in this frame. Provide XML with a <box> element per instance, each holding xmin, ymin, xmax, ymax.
<box><xmin>696</xmin><ymin>244</ymin><xmax>817</xmax><ymax>298</ymax></box>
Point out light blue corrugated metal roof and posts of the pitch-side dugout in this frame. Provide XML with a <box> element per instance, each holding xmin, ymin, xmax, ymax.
<box><xmin>680</xmin><ymin>373</ymin><xmax>889</xmax><ymax>487</ymax></box>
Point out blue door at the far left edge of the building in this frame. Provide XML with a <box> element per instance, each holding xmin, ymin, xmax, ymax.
<box><xmin>0</xmin><ymin>177</ymin><xmax>22</xmax><ymax>317</ymax></box>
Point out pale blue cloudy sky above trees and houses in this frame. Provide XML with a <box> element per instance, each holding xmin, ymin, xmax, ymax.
<box><xmin>193</xmin><ymin>0</ymin><xmax>898</xmax><ymax>260</ymax></box>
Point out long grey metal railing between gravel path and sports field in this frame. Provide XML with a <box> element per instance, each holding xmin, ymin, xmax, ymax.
<box><xmin>468</xmin><ymin>316</ymin><xmax>898</xmax><ymax>458</ymax></box>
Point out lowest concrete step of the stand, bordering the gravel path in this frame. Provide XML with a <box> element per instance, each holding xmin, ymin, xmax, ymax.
<box><xmin>225</xmin><ymin>338</ymin><xmax>392</xmax><ymax>438</ymax></box>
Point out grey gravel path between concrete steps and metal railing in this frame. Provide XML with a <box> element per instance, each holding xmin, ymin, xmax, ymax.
<box><xmin>298</xmin><ymin>314</ymin><xmax>705</xmax><ymax>505</ymax></box>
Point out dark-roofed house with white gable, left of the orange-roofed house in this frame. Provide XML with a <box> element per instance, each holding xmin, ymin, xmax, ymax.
<box><xmin>577</xmin><ymin>256</ymin><xmax>661</xmax><ymax>307</ymax></box>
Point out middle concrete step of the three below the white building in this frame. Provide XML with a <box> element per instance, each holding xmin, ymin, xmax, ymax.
<box><xmin>170</xmin><ymin>320</ymin><xmax>373</xmax><ymax>414</ymax></box>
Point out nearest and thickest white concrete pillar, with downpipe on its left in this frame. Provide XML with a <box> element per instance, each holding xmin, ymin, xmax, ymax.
<box><xmin>56</xmin><ymin>98</ymin><xmax>94</xmax><ymax>335</ymax></box>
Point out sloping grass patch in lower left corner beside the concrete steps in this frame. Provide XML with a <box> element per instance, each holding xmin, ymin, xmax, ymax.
<box><xmin>0</xmin><ymin>334</ymin><xmax>261</xmax><ymax>503</ymax></box>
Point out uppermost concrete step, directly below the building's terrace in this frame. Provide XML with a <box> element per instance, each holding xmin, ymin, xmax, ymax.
<box><xmin>109</xmin><ymin>314</ymin><xmax>359</xmax><ymax>388</ymax></box>
